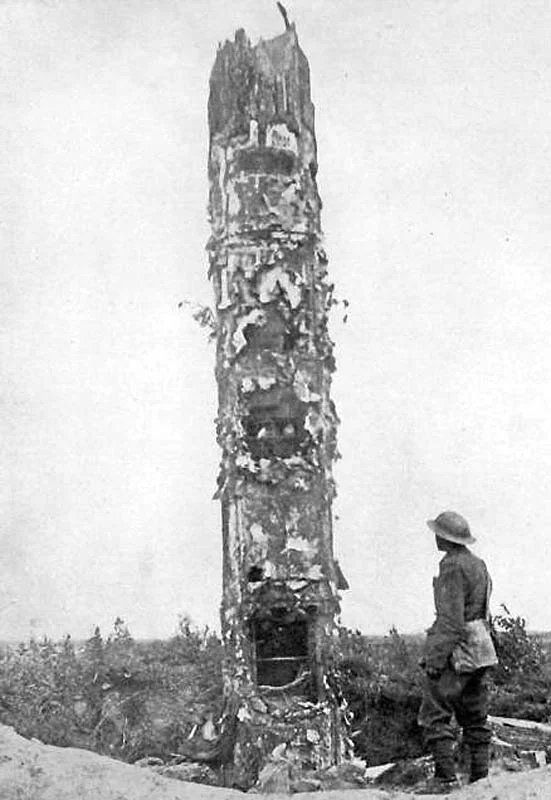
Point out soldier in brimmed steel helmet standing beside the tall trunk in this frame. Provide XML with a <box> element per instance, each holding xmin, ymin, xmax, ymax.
<box><xmin>418</xmin><ymin>511</ymin><xmax>495</xmax><ymax>794</ymax></box>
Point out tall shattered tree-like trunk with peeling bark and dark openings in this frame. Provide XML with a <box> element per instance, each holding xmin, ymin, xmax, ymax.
<box><xmin>207</xmin><ymin>17</ymin><xmax>346</xmax><ymax>785</ymax></box>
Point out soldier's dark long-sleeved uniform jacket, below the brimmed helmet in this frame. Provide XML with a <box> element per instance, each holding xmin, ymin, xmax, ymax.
<box><xmin>424</xmin><ymin>547</ymin><xmax>491</xmax><ymax>670</ymax></box>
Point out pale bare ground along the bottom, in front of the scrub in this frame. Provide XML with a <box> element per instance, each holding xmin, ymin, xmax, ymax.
<box><xmin>0</xmin><ymin>726</ymin><xmax>551</xmax><ymax>800</ymax></box>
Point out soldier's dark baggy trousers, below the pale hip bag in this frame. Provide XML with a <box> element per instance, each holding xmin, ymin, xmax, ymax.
<box><xmin>418</xmin><ymin>669</ymin><xmax>492</xmax><ymax>749</ymax></box>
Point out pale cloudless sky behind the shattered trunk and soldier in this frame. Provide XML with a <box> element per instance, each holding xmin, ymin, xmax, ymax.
<box><xmin>0</xmin><ymin>0</ymin><xmax>551</xmax><ymax>639</ymax></box>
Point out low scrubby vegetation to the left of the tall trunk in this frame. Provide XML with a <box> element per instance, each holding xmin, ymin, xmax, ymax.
<box><xmin>0</xmin><ymin>617</ymin><xmax>222</xmax><ymax>762</ymax></box>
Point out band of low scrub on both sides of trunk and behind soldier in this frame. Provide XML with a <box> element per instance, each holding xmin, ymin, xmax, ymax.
<box><xmin>0</xmin><ymin>607</ymin><xmax>551</xmax><ymax>764</ymax></box>
